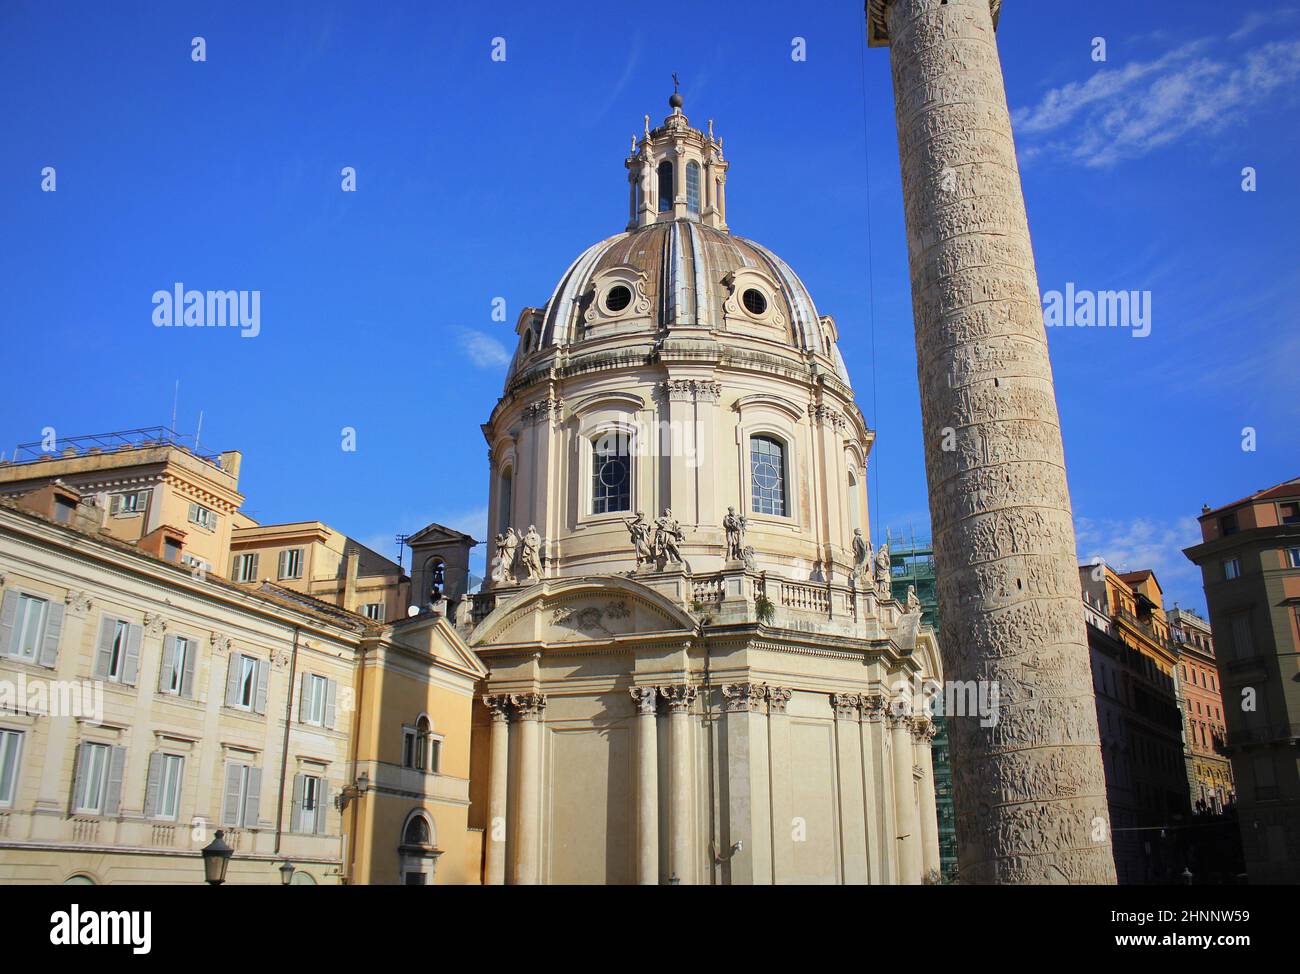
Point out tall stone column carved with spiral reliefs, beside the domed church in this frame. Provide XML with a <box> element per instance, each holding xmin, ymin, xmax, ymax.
<box><xmin>866</xmin><ymin>0</ymin><xmax>1115</xmax><ymax>883</ymax></box>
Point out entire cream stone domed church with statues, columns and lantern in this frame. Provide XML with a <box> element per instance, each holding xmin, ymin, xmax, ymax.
<box><xmin>458</xmin><ymin>95</ymin><xmax>941</xmax><ymax>884</ymax></box>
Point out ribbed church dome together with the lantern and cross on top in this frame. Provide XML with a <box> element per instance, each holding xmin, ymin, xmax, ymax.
<box><xmin>506</xmin><ymin>96</ymin><xmax>849</xmax><ymax>390</ymax></box>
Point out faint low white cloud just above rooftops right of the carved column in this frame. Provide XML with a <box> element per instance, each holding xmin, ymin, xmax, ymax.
<box><xmin>1074</xmin><ymin>516</ymin><xmax>1205</xmax><ymax>607</ymax></box>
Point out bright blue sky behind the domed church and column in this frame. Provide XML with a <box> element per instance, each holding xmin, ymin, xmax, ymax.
<box><xmin>0</xmin><ymin>0</ymin><xmax>1300</xmax><ymax>607</ymax></box>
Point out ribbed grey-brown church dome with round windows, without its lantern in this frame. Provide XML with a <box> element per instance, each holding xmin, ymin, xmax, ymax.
<box><xmin>511</xmin><ymin>220</ymin><xmax>849</xmax><ymax>382</ymax></box>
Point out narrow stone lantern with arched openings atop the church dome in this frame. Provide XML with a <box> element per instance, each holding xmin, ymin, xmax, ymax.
<box><xmin>624</xmin><ymin>74</ymin><xmax>728</xmax><ymax>230</ymax></box>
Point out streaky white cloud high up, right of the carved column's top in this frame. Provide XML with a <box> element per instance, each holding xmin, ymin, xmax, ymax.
<box><xmin>1013</xmin><ymin>14</ymin><xmax>1300</xmax><ymax>166</ymax></box>
